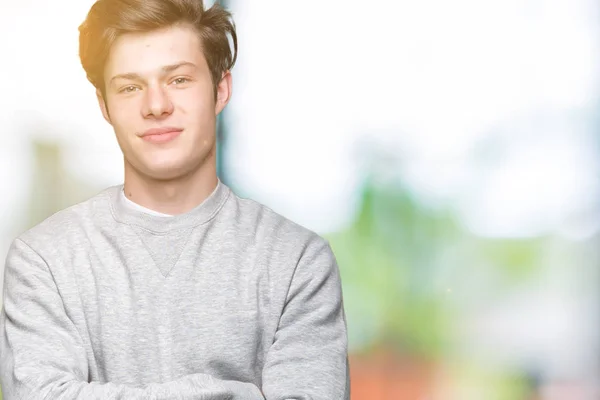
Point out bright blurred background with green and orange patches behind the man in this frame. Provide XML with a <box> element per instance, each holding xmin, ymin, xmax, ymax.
<box><xmin>0</xmin><ymin>0</ymin><xmax>600</xmax><ymax>400</ymax></box>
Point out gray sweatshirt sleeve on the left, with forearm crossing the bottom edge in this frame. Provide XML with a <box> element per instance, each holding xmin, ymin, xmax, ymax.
<box><xmin>0</xmin><ymin>239</ymin><xmax>264</xmax><ymax>400</ymax></box>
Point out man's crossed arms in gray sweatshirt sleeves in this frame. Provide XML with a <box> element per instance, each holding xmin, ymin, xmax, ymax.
<box><xmin>0</xmin><ymin>239</ymin><xmax>349</xmax><ymax>400</ymax></box>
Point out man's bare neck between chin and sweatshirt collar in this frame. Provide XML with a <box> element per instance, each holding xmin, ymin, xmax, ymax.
<box><xmin>124</xmin><ymin>158</ymin><xmax>218</xmax><ymax>215</ymax></box>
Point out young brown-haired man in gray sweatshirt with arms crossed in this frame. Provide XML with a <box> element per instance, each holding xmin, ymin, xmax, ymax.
<box><xmin>0</xmin><ymin>0</ymin><xmax>349</xmax><ymax>400</ymax></box>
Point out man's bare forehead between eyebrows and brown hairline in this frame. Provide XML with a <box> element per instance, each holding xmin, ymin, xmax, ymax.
<box><xmin>104</xmin><ymin>25</ymin><xmax>206</xmax><ymax>80</ymax></box>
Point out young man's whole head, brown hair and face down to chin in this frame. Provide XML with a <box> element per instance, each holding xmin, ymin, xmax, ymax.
<box><xmin>79</xmin><ymin>0</ymin><xmax>237</xmax><ymax>180</ymax></box>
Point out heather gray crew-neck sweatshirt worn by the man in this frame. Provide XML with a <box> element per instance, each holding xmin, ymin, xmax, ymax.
<box><xmin>0</xmin><ymin>181</ymin><xmax>350</xmax><ymax>400</ymax></box>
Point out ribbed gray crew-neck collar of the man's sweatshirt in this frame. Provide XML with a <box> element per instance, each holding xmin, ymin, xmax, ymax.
<box><xmin>105</xmin><ymin>179</ymin><xmax>231</xmax><ymax>233</ymax></box>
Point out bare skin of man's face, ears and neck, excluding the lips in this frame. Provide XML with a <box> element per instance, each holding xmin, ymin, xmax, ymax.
<box><xmin>96</xmin><ymin>25</ymin><xmax>231</xmax><ymax>215</ymax></box>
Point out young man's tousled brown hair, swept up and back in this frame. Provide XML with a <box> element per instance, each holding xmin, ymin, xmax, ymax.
<box><xmin>79</xmin><ymin>0</ymin><xmax>237</xmax><ymax>96</ymax></box>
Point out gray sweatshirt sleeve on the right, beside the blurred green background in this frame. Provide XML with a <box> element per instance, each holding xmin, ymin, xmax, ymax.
<box><xmin>262</xmin><ymin>239</ymin><xmax>350</xmax><ymax>400</ymax></box>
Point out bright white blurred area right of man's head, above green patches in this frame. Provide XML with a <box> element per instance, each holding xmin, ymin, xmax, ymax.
<box><xmin>231</xmin><ymin>0</ymin><xmax>600</xmax><ymax>237</ymax></box>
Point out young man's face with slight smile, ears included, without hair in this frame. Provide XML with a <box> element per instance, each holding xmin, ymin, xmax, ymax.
<box><xmin>97</xmin><ymin>26</ymin><xmax>231</xmax><ymax>180</ymax></box>
